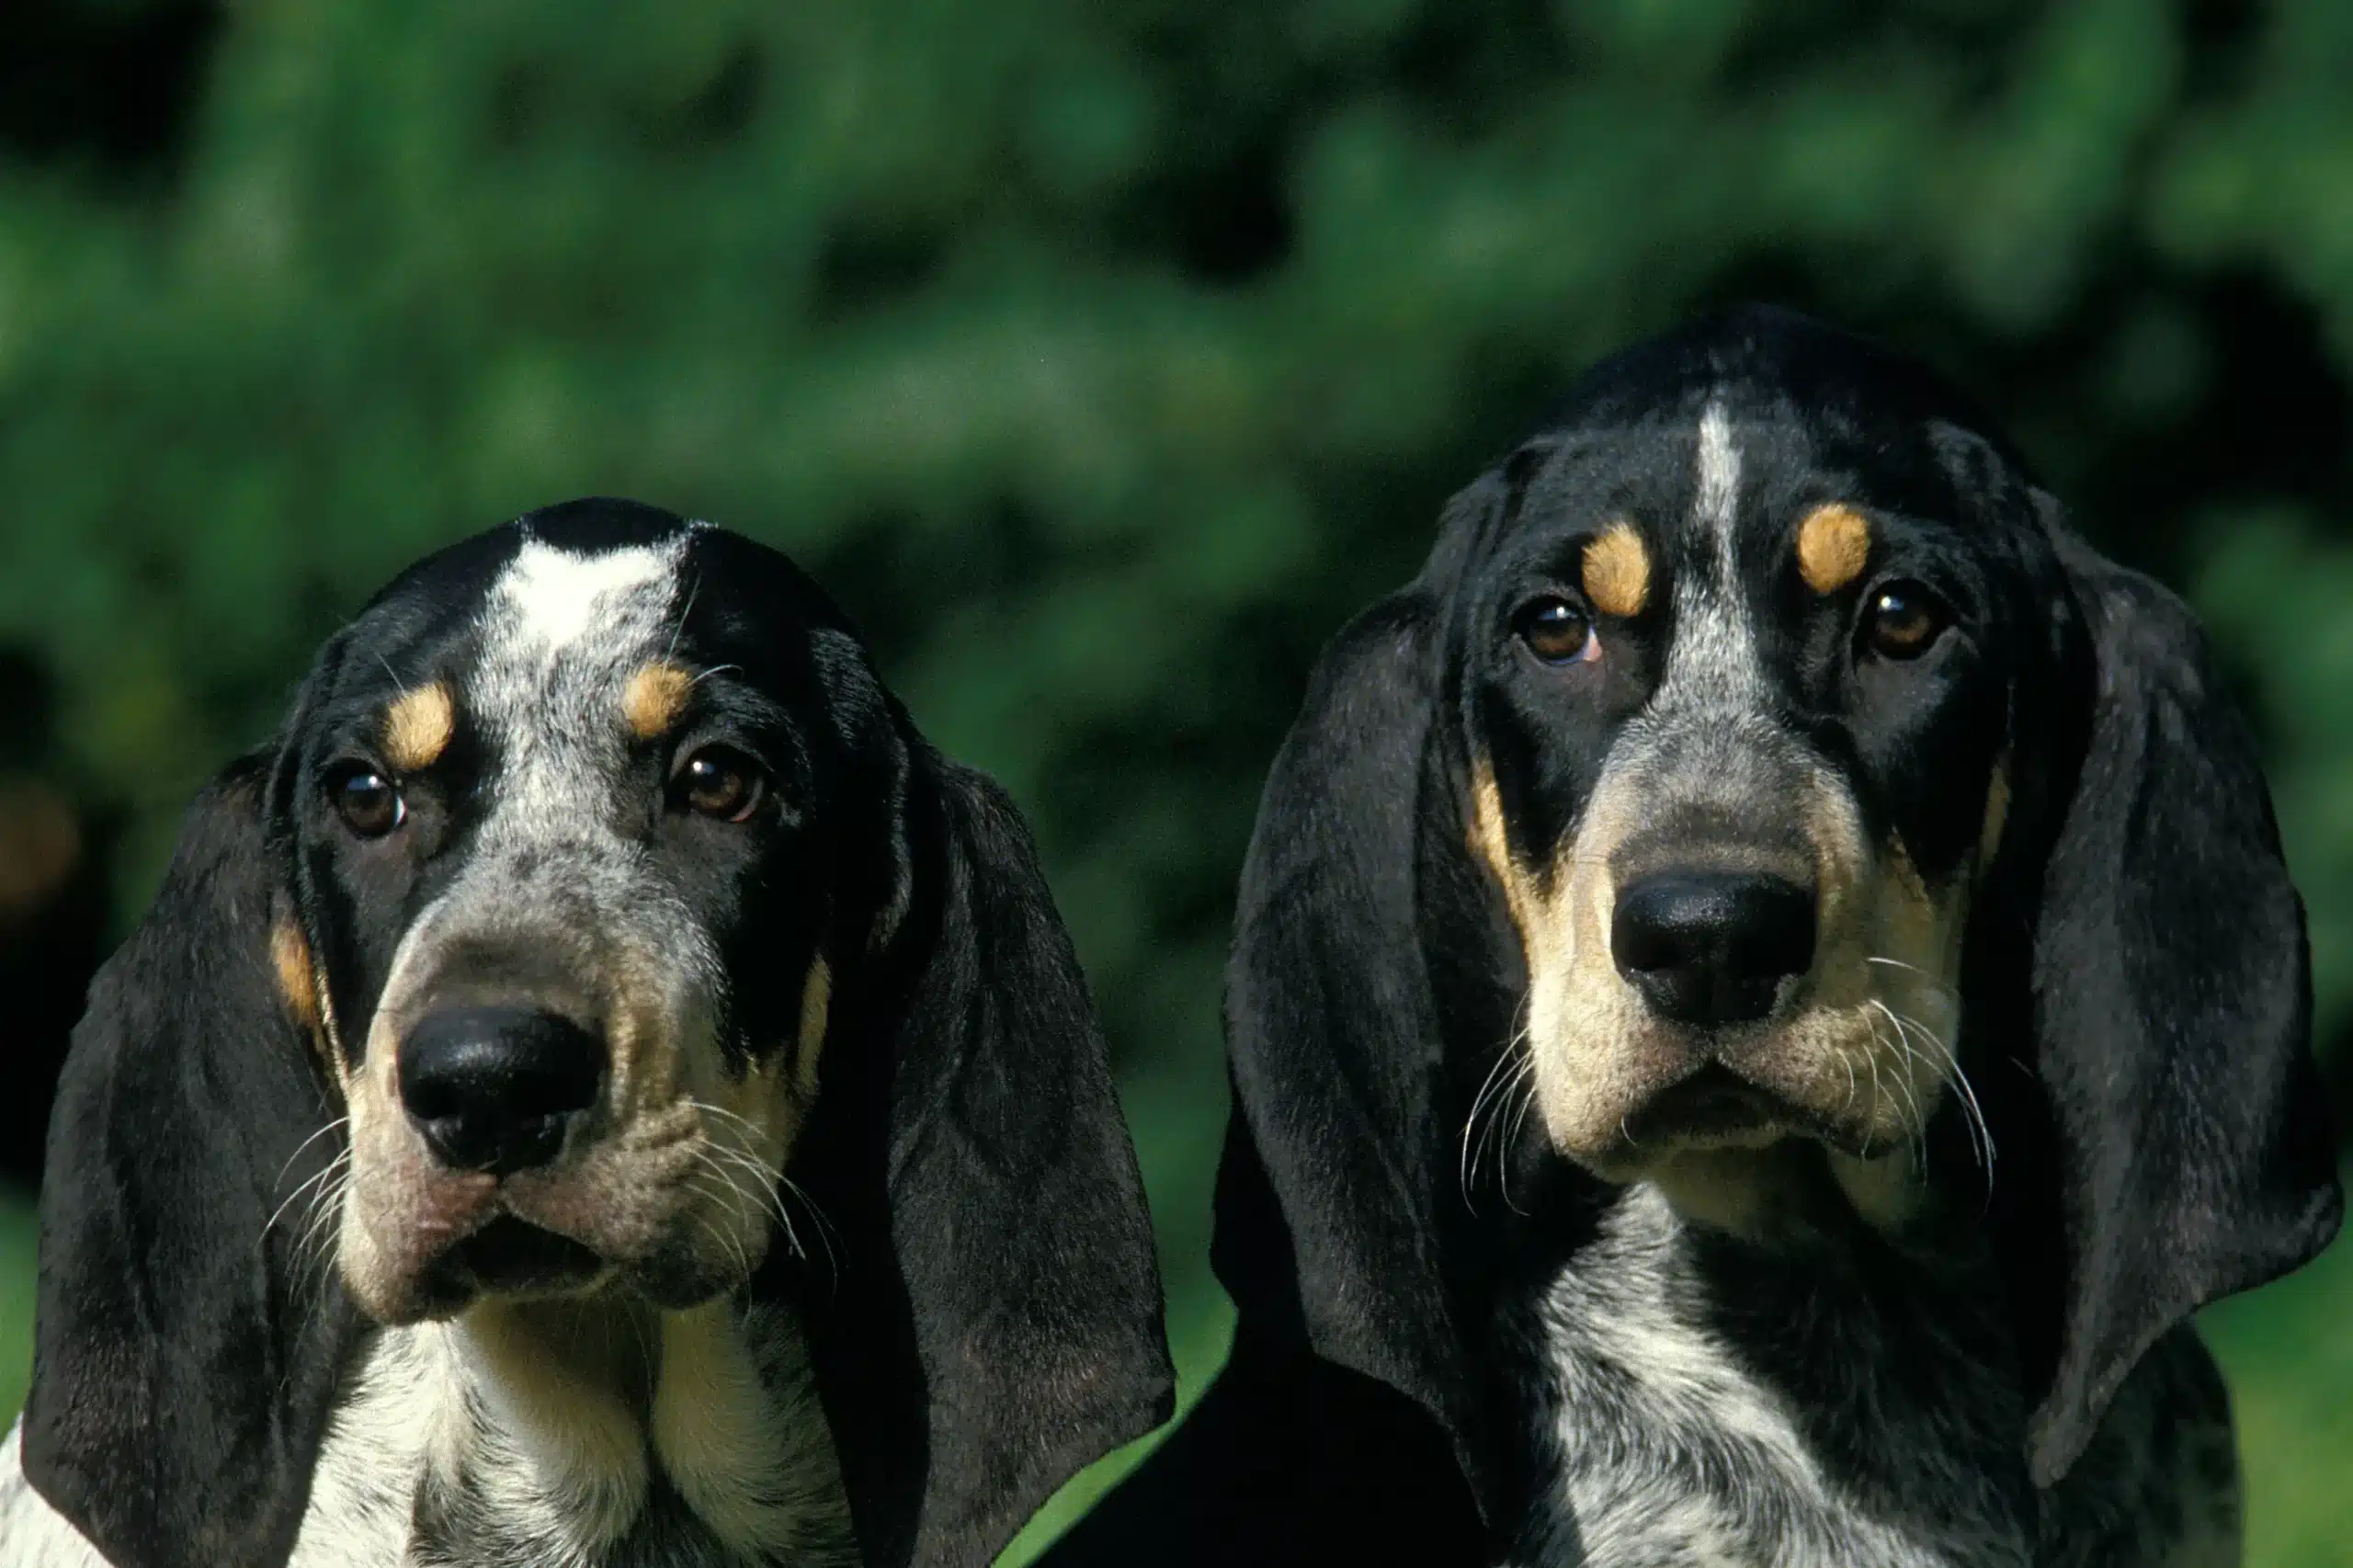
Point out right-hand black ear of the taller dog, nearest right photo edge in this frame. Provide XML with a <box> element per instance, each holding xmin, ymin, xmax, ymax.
<box><xmin>2030</xmin><ymin>532</ymin><xmax>2344</xmax><ymax>1483</ymax></box>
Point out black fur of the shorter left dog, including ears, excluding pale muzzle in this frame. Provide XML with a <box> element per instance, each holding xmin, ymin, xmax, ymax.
<box><xmin>0</xmin><ymin>502</ymin><xmax>1169</xmax><ymax>1568</ymax></box>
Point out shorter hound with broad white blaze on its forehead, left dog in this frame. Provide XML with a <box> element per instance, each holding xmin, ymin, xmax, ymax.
<box><xmin>0</xmin><ymin>502</ymin><xmax>1169</xmax><ymax>1568</ymax></box>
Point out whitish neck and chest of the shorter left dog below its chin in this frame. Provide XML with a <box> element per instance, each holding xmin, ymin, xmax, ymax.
<box><xmin>294</xmin><ymin>1297</ymin><xmax>854</xmax><ymax>1568</ymax></box>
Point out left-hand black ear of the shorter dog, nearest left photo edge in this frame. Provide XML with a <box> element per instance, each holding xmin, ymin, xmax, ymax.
<box><xmin>24</xmin><ymin>758</ymin><xmax>350</xmax><ymax>1568</ymax></box>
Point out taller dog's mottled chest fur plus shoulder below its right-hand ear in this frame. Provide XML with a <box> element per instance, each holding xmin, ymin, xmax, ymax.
<box><xmin>1506</xmin><ymin>1182</ymin><xmax>2240</xmax><ymax>1568</ymax></box>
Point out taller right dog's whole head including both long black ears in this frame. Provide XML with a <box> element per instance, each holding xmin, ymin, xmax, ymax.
<box><xmin>1219</xmin><ymin>311</ymin><xmax>2339</xmax><ymax>1514</ymax></box>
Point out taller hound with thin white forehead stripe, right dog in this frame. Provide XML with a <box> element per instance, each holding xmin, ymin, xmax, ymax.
<box><xmin>1062</xmin><ymin>311</ymin><xmax>2341</xmax><ymax>1568</ymax></box>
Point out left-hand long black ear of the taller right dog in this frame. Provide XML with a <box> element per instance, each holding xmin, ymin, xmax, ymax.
<box><xmin>1217</xmin><ymin>579</ymin><xmax>1504</xmax><ymax>1505</ymax></box>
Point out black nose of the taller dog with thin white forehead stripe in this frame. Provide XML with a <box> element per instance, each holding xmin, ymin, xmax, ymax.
<box><xmin>1609</xmin><ymin>871</ymin><xmax>1814</xmax><ymax>1024</ymax></box>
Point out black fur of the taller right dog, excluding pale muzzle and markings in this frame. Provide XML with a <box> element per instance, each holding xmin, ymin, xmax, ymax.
<box><xmin>1054</xmin><ymin>311</ymin><xmax>2341</xmax><ymax>1565</ymax></box>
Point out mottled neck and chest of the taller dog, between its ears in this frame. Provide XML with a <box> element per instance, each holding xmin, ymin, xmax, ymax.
<box><xmin>1511</xmin><ymin>1170</ymin><xmax>2035</xmax><ymax>1568</ymax></box>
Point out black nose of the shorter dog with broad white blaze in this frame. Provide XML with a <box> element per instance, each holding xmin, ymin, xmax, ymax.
<box><xmin>400</xmin><ymin>1007</ymin><xmax>605</xmax><ymax>1175</ymax></box>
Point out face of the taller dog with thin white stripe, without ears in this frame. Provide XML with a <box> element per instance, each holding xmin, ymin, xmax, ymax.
<box><xmin>1463</xmin><ymin>374</ymin><xmax>2030</xmax><ymax>1179</ymax></box>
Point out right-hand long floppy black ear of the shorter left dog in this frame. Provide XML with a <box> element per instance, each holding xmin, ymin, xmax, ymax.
<box><xmin>802</xmin><ymin>737</ymin><xmax>1174</xmax><ymax>1568</ymax></box>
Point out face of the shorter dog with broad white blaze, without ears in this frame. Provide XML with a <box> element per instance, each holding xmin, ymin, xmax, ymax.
<box><xmin>273</xmin><ymin>518</ymin><xmax>854</xmax><ymax>1324</ymax></box>
